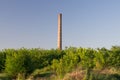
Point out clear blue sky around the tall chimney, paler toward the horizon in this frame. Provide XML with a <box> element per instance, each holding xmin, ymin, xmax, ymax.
<box><xmin>0</xmin><ymin>0</ymin><xmax>120</xmax><ymax>49</ymax></box>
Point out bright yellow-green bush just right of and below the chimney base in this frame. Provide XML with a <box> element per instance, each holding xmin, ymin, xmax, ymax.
<box><xmin>52</xmin><ymin>47</ymin><xmax>80</xmax><ymax>77</ymax></box>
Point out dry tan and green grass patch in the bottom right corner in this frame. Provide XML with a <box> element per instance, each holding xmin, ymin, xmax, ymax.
<box><xmin>89</xmin><ymin>67</ymin><xmax>120</xmax><ymax>80</ymax></box>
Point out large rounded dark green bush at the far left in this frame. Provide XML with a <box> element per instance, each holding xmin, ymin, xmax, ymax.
<box><xmin>5</xmin><ymin>49</ymin><xmax>32</xmax><ymax>76</ymax></box>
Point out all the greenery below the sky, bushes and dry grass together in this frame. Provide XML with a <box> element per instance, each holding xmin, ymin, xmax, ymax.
<box><xmin>0</xmin><ymin>46</ymin><xmax>120</xmax><ymax>80</ymax></box>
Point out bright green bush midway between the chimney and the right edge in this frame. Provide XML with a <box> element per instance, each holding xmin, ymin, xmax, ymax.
<box><xmin>78</xmin><ymin>48</ymin><xmax>97</xmax><ymax>69</ymax></box>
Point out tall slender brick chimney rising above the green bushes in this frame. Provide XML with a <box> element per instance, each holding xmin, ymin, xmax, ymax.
<box><xmin>57</xmin><ymin>13</ymin><xmax>62</xmax><ymax>50</ymax></box>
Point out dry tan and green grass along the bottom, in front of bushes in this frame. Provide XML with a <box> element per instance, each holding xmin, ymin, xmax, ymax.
<box><xmin>0</xmin><ymin>68</ymin><xmax>120</xmax><ymax>80</ymax></box>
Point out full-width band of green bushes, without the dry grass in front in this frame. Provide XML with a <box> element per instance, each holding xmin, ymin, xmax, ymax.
<box><xmin>0</xmin><ymin>46</ymin><xmax>120</xmax><ymax>79</ymax></box>
